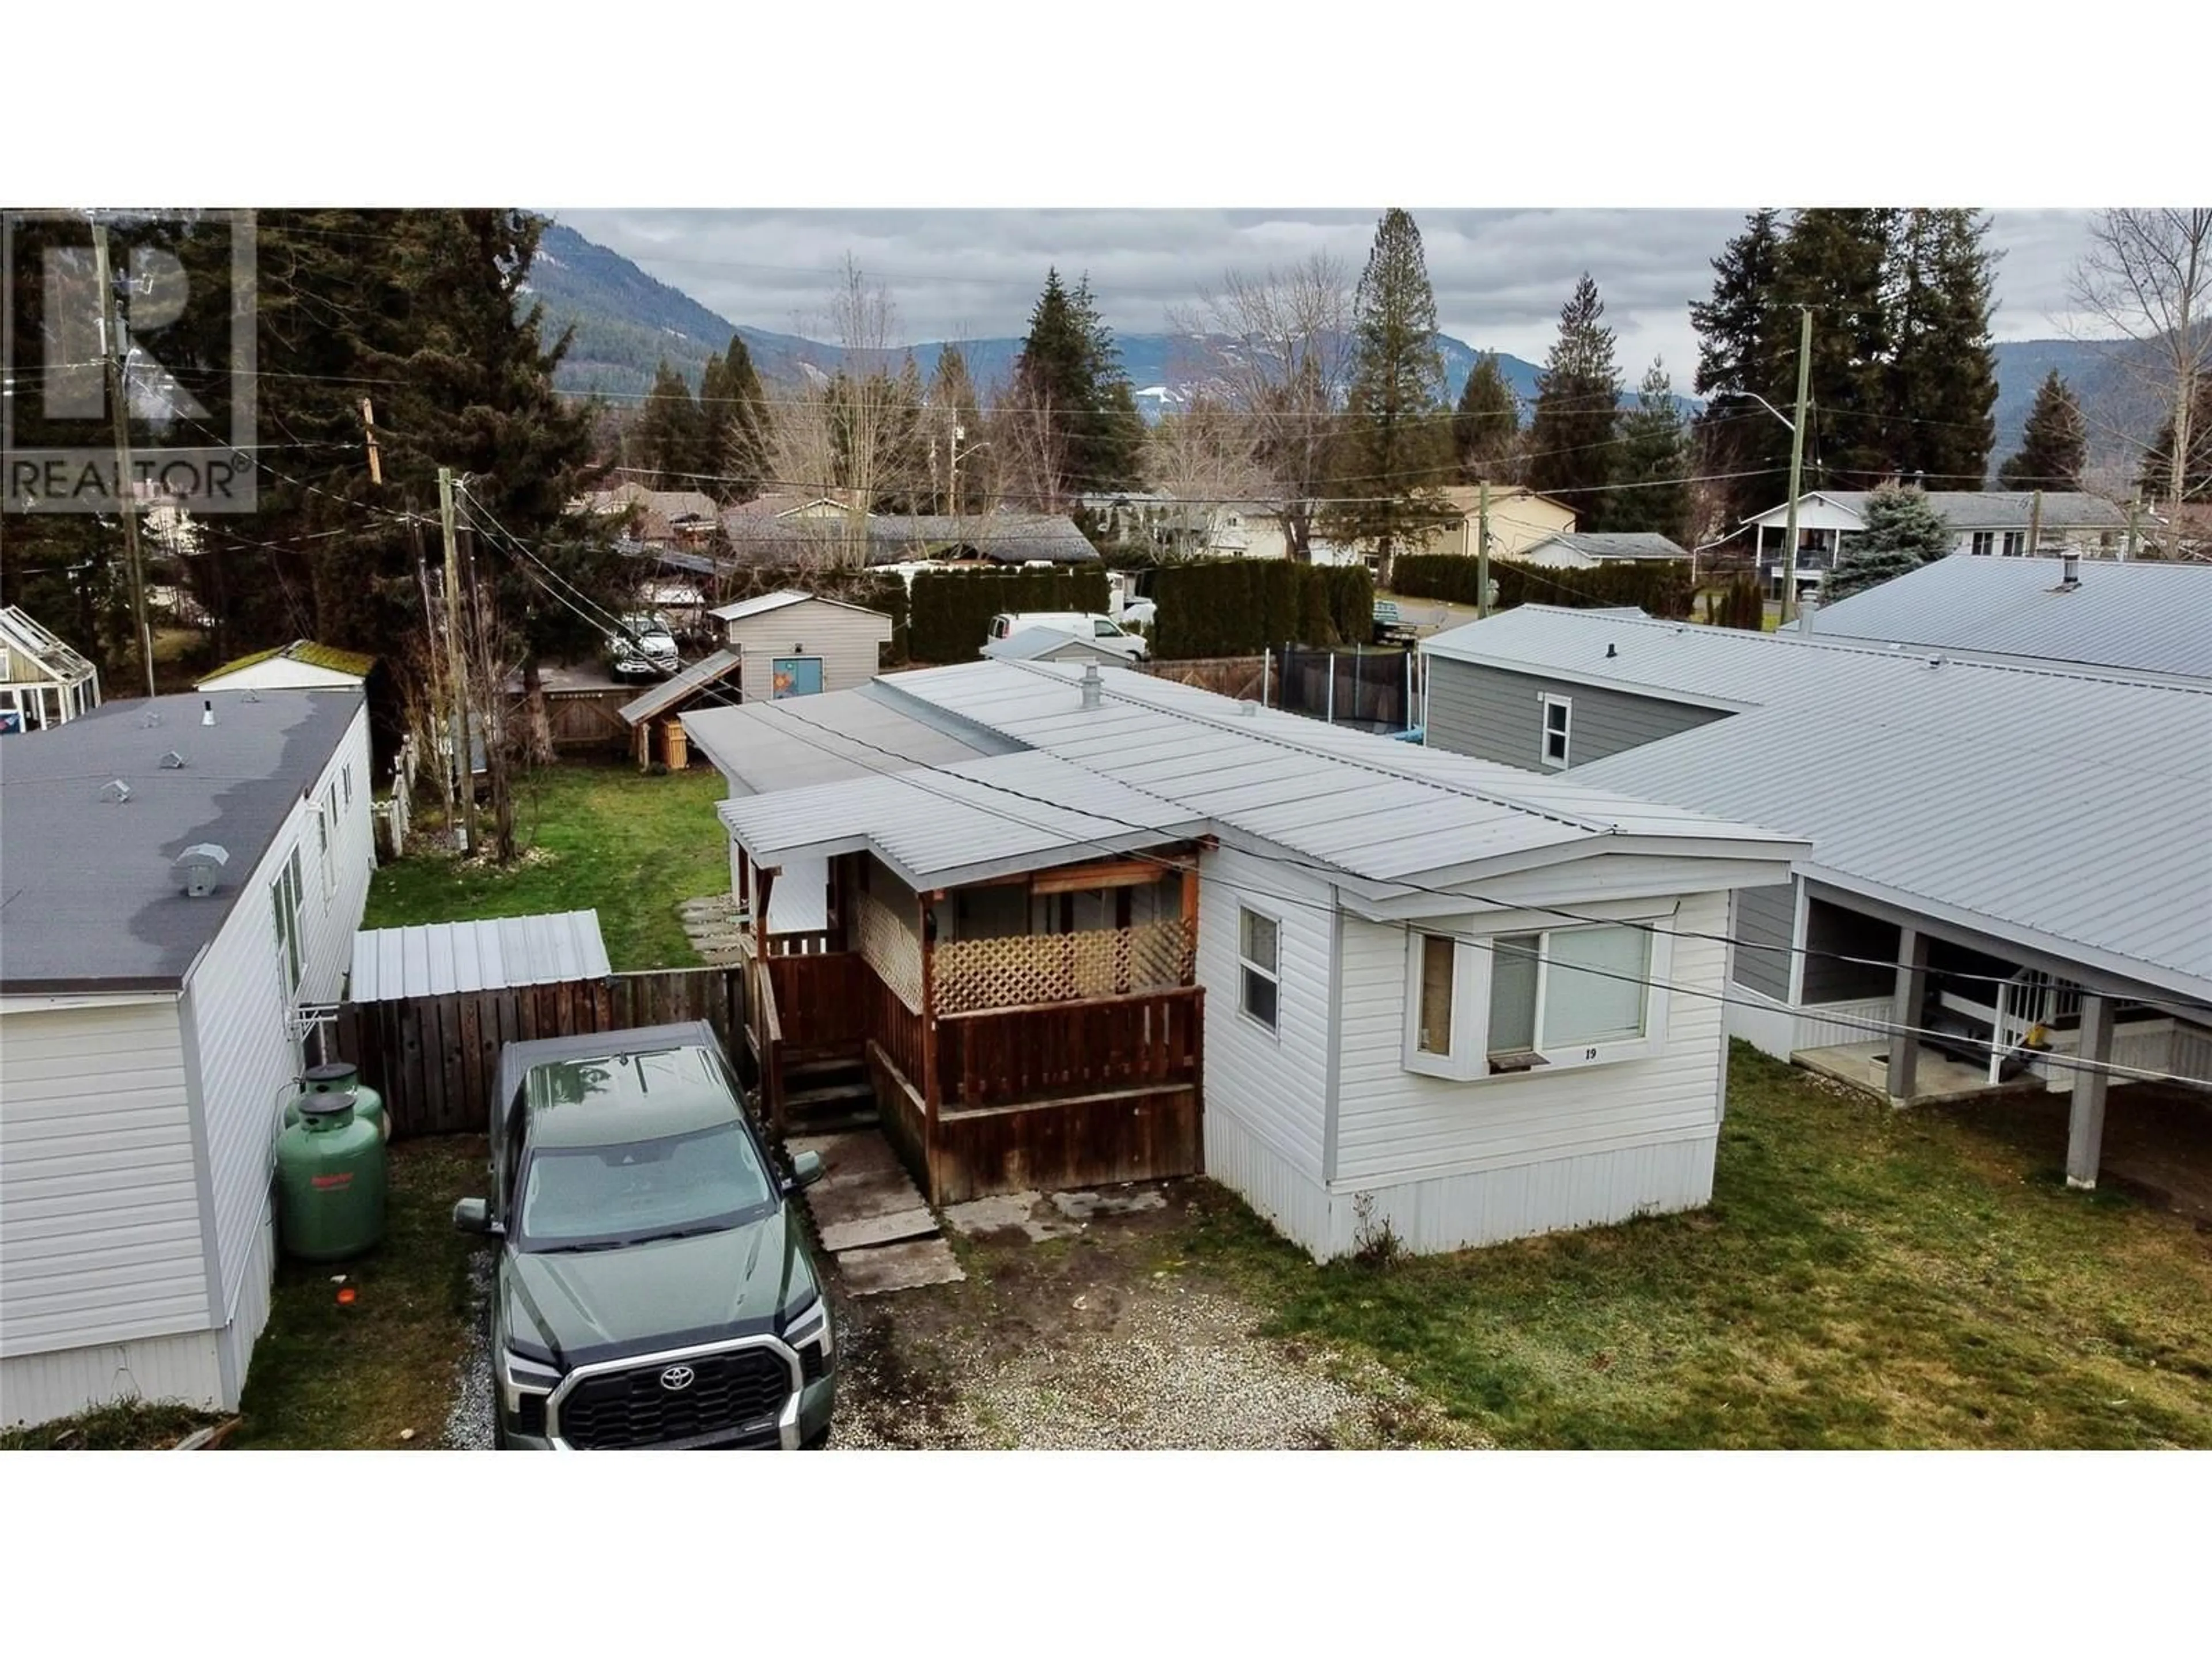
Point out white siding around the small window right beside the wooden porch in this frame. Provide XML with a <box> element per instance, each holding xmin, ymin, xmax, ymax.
<box><xmin>1199</xmin><ymin>847</ymin><xmax>1334</xmax><ymax>1183</ymax></box>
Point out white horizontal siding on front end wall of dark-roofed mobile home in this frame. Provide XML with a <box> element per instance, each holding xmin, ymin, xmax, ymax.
<box><xmin>0</xmin><ymin>995</ymin><xmax>207</xmax><ymax>1354</ymax></box>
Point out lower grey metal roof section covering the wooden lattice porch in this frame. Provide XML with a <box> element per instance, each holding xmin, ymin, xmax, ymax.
<box><xmin>719</xmin><ymin>752</ymin><xmax>1206</xmax><ymax>889</ymax></box>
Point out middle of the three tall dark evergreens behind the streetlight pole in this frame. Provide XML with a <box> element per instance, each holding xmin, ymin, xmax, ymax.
<box><xmin>1770</xmin><ymin>208</ymin><xmax>1898</xmax><ymax>486</ymax></box>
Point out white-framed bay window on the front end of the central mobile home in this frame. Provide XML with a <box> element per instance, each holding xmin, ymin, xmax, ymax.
<box><xmin>1404</xmin><ymin>922</ymin><xmax>1668</xmax><ymax>1080</ymax></box>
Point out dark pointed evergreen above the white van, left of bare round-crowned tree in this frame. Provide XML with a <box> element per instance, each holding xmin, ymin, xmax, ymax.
<box><xmin>1011</xmin><ymin>270</ymin><xmax>1143</xmax><ymax>505</ymax></box>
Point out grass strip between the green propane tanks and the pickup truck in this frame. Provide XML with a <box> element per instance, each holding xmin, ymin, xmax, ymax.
<box><xmin>226</xmin><ymin>1135</ymin><xmax>487</xmax><ymax>1451</ymax></box>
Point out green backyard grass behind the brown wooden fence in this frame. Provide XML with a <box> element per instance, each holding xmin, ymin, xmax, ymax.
<box><xmin>361</xmin><ymin>761</ymin><xmax>730</xmax><ymax>974</ymax></box>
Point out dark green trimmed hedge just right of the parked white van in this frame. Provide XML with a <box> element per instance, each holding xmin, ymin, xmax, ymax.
<box><xmin>1153</xmin><ymin>560</ymin><xmax>1376</xmax><ymax>661</ymax></box>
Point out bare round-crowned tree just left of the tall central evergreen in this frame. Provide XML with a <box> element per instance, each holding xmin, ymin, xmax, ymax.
<box><xmin>1170</xmin><ymin>252</ymin><xmax>1351</xmax><ymax>562</ymax></box>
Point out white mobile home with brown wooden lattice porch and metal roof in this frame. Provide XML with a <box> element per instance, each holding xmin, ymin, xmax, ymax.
<box><xmin>685</xmin><ymin>661</ymin><xmax>1801</xmax><ymax>1259</ymax></box>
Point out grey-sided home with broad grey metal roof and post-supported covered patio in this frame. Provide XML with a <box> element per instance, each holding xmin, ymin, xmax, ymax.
<box><xmin>1422</xmin><ymin>610</ymin><xmax>2212</xmax><ymax>1185</ymax></box>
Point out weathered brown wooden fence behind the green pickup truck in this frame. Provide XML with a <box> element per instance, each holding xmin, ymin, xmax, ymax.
<box><xmin>332</xmin><ymin>967</ymin><xmax>745</xmax><ymax>1137</ymax></box>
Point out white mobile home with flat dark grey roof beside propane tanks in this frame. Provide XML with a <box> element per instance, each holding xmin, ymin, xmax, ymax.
<box><xmin>0</xmin><ymin>688</ymin><xmax>374</xmax><ymax>1422</ymax></box>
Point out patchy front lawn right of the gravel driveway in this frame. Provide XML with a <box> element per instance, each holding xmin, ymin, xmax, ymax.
<box><xmin>1166</xmin><ymin>1044</ymin><xmax>2212</xmax><ymax>1446</ymax></box>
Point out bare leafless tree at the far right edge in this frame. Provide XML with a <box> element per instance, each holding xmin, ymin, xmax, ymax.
<box><xmin>2070</xmin><ymin>208</ymin><xmax>2212</xmax><ymax>535</ymax></box>
